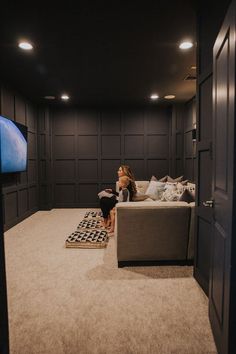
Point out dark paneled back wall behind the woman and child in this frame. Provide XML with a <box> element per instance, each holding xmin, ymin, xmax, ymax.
<box><xmin>47</xmin><ymin>108</ymin><xmax>171</xmax><ymax>207</ymax></box>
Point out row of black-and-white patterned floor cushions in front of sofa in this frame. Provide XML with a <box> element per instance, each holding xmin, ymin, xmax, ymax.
<box><xmin>66</xmin><ymin>211</ymin><xmax>109</xmax><ymax>248</ymax></box>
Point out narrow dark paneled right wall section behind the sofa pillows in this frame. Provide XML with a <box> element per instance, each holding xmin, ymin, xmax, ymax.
<box><xmin>184</xmin><ymin>98</ymin><xmax>196</xmax><ymax>181</ymax></box>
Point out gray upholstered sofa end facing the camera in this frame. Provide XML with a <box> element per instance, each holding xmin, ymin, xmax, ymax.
<box><xmin>115</xmin><ymin>181</ymin><xmax>195</xmax><ymax>266</ymax></box>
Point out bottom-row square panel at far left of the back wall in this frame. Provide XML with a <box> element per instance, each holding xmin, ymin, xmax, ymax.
<box><xmin>54</xmin><ymin>183</ymin><xmax>76</xmax><ymax>205</ymax></box>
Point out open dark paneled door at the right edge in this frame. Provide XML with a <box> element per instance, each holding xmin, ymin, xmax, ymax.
<box><xmin>209</xmin><ymin>1</ymin><xmax>236</xmax><ymax>353</ymax></box>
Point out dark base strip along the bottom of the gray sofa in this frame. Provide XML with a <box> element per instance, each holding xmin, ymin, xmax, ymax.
<box><xmin>118</xmin><ymin>259</ymin><xmax>193</xmax><ymax>268</ymax></box>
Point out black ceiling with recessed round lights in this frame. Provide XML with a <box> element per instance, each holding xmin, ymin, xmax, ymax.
<box><xmin>0</xmin><ymin>0</ymin><xmax>196</xmax><ymax>105</ymax></box>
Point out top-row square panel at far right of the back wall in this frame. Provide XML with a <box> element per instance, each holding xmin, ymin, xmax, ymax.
<box><xmin>146</xmin><ymin>109</ymin><xmax>171</xmax><ymax>134</ymax></box>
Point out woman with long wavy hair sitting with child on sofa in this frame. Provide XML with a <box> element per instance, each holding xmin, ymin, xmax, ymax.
<box><xmin>100</xmin><ymin>165</ymin><xmax>137</xmax><ymax>227</ymax></box>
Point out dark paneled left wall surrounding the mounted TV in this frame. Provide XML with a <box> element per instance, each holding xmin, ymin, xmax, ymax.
<box><xmin>1</xmin><ymin>87</ymin><xmax>38</xmax><ymax>229</ymax></box>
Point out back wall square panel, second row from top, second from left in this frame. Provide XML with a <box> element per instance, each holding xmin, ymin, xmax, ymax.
<box><xmin>78</xmin><ymin>135</ymin><xmax>98</xmax><ymax>157</ymax></box>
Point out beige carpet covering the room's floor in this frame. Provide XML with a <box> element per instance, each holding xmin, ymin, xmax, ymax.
<box><xmin>5</xmin><ymin>209</ymin><xmax>216</xmax><ymax>354</ymax></box>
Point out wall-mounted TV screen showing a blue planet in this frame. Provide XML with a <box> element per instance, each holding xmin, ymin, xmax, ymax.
<box><xmin>0</xmin><ymin>116</ymin><xmax>27</xmax><ymax>173</ymax></box>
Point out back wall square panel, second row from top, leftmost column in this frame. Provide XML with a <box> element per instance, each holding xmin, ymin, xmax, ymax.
<box><xmin>53</xmin><ymin>135</ymin><xmax>75</xmax><ymax>159</ymax></box>
